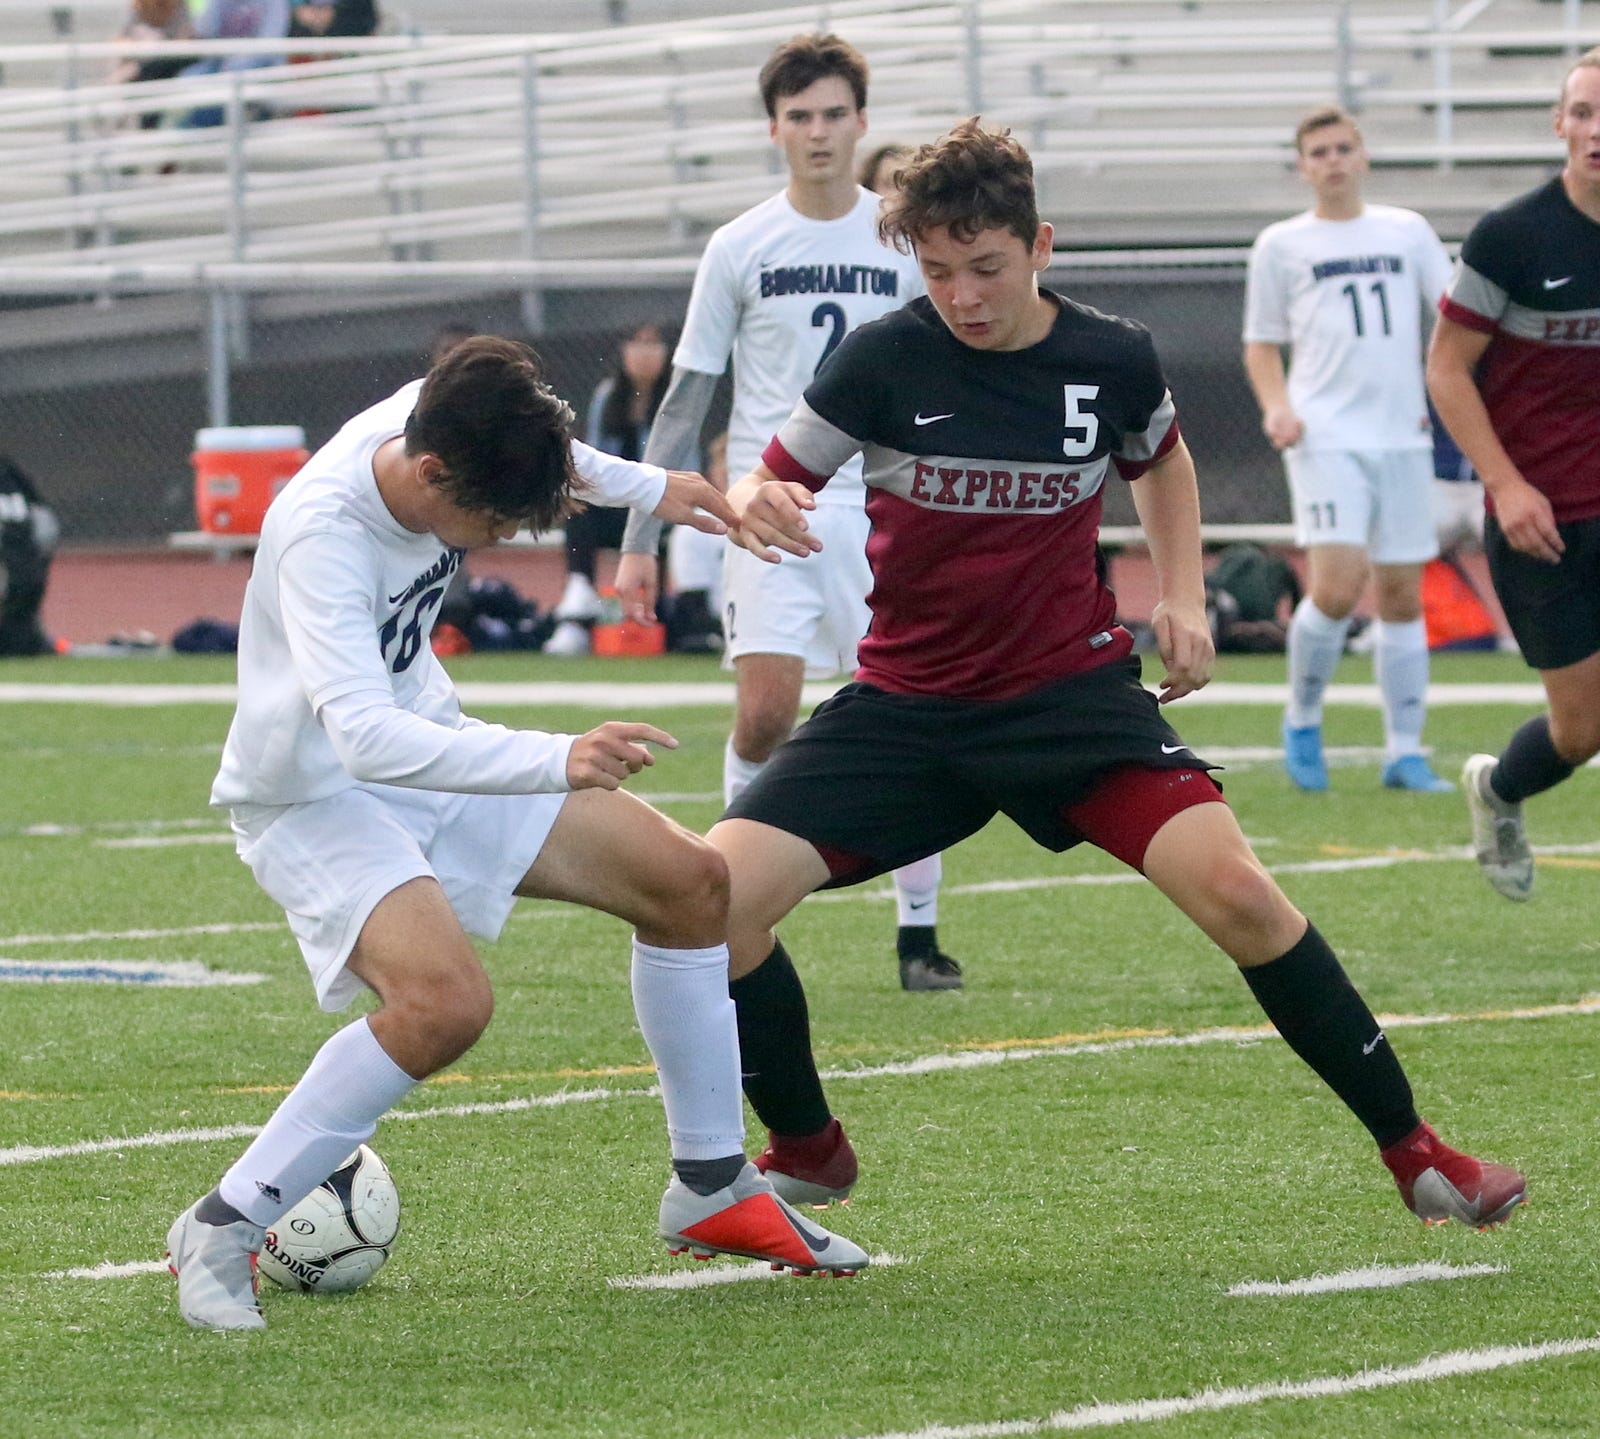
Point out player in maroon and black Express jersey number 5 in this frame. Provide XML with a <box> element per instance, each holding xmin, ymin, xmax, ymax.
<box><xmin>709</xmin><ymin>120</ymin><xmax>1525</xmax><ymax>1225</ymax></box>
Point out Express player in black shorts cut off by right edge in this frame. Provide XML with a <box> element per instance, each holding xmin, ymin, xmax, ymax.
<box><xmin>1427</xmin><ymin>48</ymin><xmax>1600</xmax><ymax>900</ymax></box>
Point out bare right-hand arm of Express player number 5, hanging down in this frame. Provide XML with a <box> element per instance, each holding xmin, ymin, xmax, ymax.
<box><xmin>1131</xmin><ymin>439</ymin><xmax>1216</xmax><ymax>704</ymax></box>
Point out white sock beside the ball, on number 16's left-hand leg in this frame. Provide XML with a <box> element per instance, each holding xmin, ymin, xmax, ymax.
<box><xmin>218</xmin><ymin>1020</ymin><xmax>416</xmax><ymax>1226</ymax></box>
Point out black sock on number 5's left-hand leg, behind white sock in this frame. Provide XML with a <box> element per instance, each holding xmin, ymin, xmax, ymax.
<box><xmin>729</xmin><ymin>940</ymin><xmax>834</xmax><ymax>1139</ymax></box>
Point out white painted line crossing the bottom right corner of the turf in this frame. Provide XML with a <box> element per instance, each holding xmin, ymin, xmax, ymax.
<box><xmin>870</xmin><ymin>1337</ymin><xmax>1600</xmax><ymax>1439</ymax></box>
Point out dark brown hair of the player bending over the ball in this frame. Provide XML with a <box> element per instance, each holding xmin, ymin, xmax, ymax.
<box><xmin>405</xmin><ymin>335</ymin><xmax>581</xmax><ymax>530</ymax></box>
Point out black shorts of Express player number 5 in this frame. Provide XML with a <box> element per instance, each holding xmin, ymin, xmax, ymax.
<box><xmin>723</xmin><ymin>656</ymin><xmax>1216</xmax><ymax>887</ymax></box>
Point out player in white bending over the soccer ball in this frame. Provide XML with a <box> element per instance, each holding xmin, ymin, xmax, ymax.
<box><xmin>166</xmin><ymin>336</ymin><xmax>861</xmax><ymax>1329</ymax></box>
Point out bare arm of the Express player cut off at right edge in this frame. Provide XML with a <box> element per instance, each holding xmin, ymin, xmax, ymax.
<box><xmin>1427</xmin><ymin>314</ymin><xmax>1566</xmax><ymax>565</ymax></box>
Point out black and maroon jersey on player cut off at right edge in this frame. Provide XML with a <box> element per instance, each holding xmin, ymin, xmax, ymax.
<box><xmin>1438</xmin><ymin>176</ymin><xmax>1600</xmax><ymax>523</ymax></box>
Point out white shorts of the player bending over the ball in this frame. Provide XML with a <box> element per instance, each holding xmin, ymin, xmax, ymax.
<box><xmin>234</xmin><ymin>784</ymin><xmax>566</xmax><ymax>1010</ymax></box>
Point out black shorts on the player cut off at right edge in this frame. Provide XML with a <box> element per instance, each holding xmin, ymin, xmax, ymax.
<box><xmin>1483</xmin><ymin>515</ymin><xmax>1600</xmax><ymax>669</ymax></box>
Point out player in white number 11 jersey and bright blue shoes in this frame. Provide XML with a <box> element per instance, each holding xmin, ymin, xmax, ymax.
<box><xmin>1245</xmin><ymin>107</ymin><xmax>1454</xmax><ymax>792</ymax></box>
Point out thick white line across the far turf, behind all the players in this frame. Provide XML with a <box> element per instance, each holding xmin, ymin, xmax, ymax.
<box><xmin>0</xmin><ymin>680</ymin><xmax>1546</xmax><ymax>709</ymax></box>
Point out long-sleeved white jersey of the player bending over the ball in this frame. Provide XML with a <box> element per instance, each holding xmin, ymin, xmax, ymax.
<box><xmin>211</xmin><ymin>381</ymin><xmax>666</xmax><ymax>818</ymax></box>
